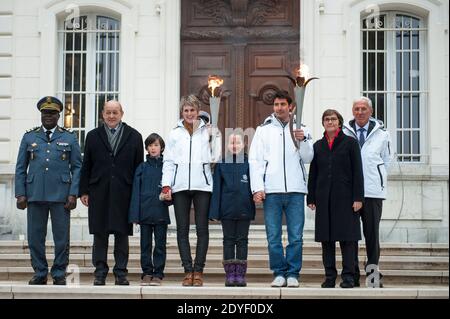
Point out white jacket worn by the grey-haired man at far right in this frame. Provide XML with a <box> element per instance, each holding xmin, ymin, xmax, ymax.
<box><xmin>343</xmin><ymin>118</ymin><xmax>393</xmax><ymax>199</ymax></box>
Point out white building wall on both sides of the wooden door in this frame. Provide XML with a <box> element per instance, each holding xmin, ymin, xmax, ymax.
<box><xmin>0</xmin><ymin>0</ymin><xmax>449</xmax><ymax>242</ymax></box>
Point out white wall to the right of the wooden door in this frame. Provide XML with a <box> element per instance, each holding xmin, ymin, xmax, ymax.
<box><xmin>301</xmin><ymin>0</ymin><xmax>449</xmax><ymax>242</ymax></box>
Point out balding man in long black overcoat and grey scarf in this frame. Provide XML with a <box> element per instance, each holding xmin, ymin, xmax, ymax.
<box><xmin>79</xmin><ymin>101</ymin><xmax>144</xmax><ymax>286</ymax></box>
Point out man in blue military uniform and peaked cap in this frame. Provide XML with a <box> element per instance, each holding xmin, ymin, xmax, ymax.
<box><xmin>15</xmin><ymin>96</ymin><xmax>81</xmax><ymax>285</ymax></box>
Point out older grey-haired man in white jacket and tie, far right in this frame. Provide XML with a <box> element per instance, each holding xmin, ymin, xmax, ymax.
<box><xmin>343</xmin><ymin>97</ymin><xmax>392</xmax><ymax>287</ymax></box>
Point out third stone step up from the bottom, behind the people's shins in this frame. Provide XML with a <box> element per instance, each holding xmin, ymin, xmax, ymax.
<box><xmin>0</xmin><ymin>253</ymin><xmax>449</xmax><ymax>270</ymax></box>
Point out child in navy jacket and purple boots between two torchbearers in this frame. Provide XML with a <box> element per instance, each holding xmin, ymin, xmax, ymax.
<box><xmin>209</xmin><ymin>134</ymin><xmax>255</xmax><ymax>286</ymax></box>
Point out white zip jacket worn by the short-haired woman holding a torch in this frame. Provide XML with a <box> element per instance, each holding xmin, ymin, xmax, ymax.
<box><xmin>161</xmin><ymin>120</ymin><xmax>220</xmax><ymax>193</ymax></box>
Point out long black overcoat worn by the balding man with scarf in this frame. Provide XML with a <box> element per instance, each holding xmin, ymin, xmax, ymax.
<box><xmin>80</xmin><ymin>123</ymin><xmax>144</xmax><ymax>235</ymax></box>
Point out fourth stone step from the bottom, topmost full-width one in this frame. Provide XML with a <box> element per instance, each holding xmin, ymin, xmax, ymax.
<box><xmin>0</xmin><ymin>242</ymin><xmax>449</xmax><ymax>256</ymax></box>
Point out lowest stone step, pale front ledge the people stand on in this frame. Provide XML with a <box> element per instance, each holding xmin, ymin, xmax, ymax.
<box><xmin>0</xmin><ymin>282</ymin><xmax>449</xmax><ymax>305</ymax></box>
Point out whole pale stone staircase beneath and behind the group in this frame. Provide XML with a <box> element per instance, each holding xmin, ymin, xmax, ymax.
<box><xmin>0</xmin><ymin>228</ymin><xmax>449</xmax><ymax>298</ymax></box>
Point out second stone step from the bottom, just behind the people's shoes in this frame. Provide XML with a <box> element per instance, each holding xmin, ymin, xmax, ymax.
<box><xmin>0</xmin><ymin>266</ymin><xmax>448</xmax><ymax>287</ymax></box>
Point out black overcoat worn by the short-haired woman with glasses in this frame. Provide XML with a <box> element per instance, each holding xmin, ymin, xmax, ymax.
<box><xmin>307</xmin><ymin>131</ymin><xmax>364</xmax><ymax>242</ymax></box>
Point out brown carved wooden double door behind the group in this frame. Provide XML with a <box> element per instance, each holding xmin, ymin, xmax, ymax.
<box><xmin>181</xmin><ymin>0</ymin><xmax>300</xmax><ymax>224</ymax></box>
